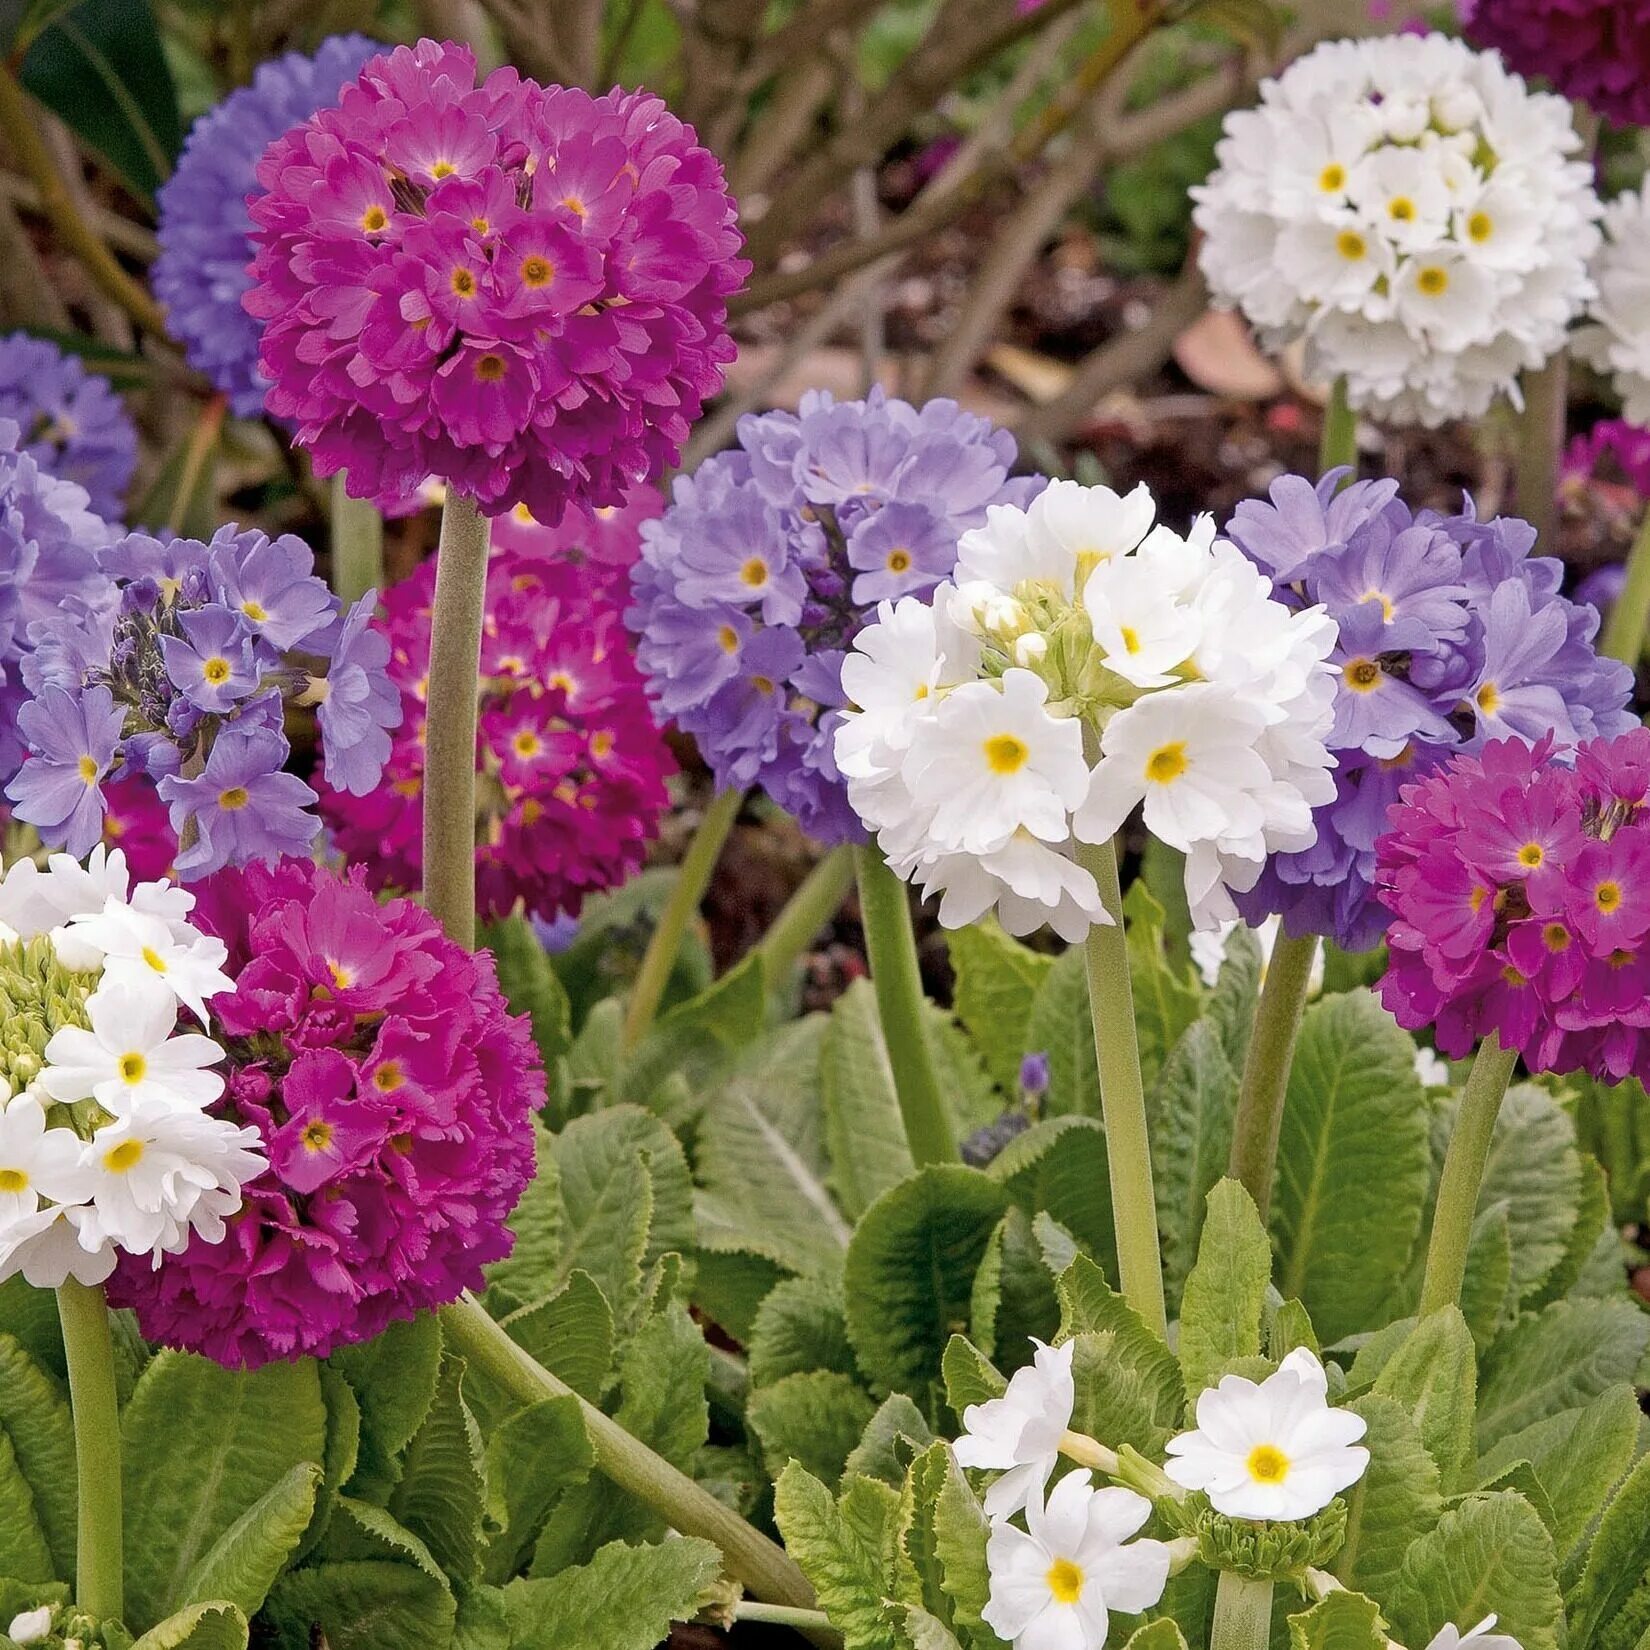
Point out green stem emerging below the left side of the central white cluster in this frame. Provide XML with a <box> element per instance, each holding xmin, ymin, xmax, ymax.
<box><xmin>855</xmin><ymin>843</ymin><xmax>960</xmax><ymax>1168</ymax></box>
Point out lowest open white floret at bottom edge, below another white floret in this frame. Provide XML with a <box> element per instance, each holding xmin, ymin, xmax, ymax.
<box><xmin>980</xmin><ymin>1472</ymin><xmax>1170</xmax><ymax>1650</ymax></box>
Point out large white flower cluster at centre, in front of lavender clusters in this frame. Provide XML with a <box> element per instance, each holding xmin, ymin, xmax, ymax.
<box><xmin>835</xmin><ymin>482</ymin><xmax>1335</xmax><ymax>941</ymax></box>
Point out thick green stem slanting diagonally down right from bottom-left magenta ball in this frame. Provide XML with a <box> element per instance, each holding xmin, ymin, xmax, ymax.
<box><xmin>441</xmin><ymin>1295</ymin><xmax>817</xmax><ymax>1610</ymax></box>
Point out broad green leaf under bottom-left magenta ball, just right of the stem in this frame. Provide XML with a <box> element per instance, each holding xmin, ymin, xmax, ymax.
<box><xmin>120</xmin><ymin>1351</ymin><xmax>327</xmax><ymax>1625</ymax></box>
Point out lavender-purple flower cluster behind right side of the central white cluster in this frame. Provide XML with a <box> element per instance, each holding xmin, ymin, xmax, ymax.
<box><xmin>1228</xmin><ymin>470</ymin><xmax>1632</xmax><ymax>950</ymax></box>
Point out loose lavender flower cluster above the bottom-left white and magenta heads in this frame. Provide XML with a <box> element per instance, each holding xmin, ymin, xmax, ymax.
<box><xmin>7</xmin><ymin>526</ymin><xmax>401</xmax><ymax>878</ymax></box>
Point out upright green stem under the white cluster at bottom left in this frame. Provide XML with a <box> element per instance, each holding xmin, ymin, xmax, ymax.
<box><xmin>58</xmin><ymin>1277</ymin><xmax>124</xmax><ymax>1620</ymax></box>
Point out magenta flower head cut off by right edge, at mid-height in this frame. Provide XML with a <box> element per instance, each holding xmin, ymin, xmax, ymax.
<box><xmin>1376</xmin><ymin>728</ymin><xmax>1650</xmax><ymax>1082</ymax></box>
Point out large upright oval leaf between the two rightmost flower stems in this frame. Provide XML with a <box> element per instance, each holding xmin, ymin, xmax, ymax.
<box><xmin>1271</xmin><ymin>992</ymin><xmax>1432</xmax><ymax>1341</ymax></box>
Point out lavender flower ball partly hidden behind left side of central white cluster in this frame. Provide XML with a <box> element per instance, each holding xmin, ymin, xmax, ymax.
<box><xmin>627</xmin><ymin>389</ymin><xmax>1041</xmax><ymax>843</ymax></box>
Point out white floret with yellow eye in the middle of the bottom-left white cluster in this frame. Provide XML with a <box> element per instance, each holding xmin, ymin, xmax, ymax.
<box><xmin>40</xmin><ymin>978</ymin><xmax>223</xmax><ymax>1115</ymax></box>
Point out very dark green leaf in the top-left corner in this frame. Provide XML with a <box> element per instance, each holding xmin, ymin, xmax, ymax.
<box><xmin>20</xmin><ymin>0</ymin><xmax>183</xmax><ymax>198</ymax></box>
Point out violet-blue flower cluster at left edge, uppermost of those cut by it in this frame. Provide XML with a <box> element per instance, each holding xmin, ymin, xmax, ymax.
<box><xmin>0</xmin><ymin>332</ymin><xmax>137</xmax><ymax>521</ymax></box>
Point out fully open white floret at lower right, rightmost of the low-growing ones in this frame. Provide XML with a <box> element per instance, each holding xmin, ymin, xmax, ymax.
<box><xmin>1165</xmin><ymin>1348</ymin><xmax>1370</xmax><ymax>1520</ymax></box>
